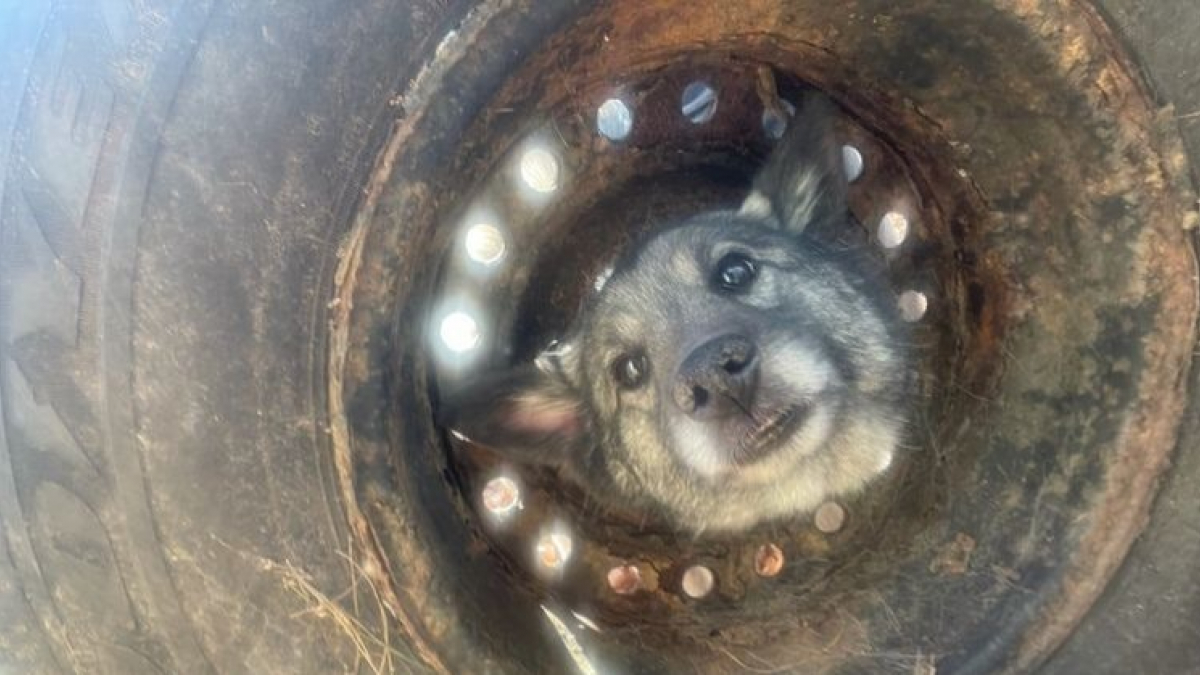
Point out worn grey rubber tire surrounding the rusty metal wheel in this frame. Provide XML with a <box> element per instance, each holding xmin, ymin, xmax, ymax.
<box><xmin>0</xmin><ymin>0</ymin><xmax>1200</xmax><ymax>674</ymax></box>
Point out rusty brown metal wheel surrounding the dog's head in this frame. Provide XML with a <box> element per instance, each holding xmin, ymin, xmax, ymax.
<box><xmin>330</xmin><ymin>0</ymin><xmax>1196</xmax><ymax>673</ymax></box>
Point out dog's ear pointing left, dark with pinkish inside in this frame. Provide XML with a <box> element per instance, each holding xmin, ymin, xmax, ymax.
<box><xmin>438</xmin><ymin>364</ymin><xmax>592</xmax><ymax>466</ymax></box>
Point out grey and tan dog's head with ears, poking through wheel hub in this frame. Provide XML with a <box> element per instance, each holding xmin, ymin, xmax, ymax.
<box><xmin>443</xmin><ymin>97</ymin><xmax>907</xmax><ymax>531</ymax></box>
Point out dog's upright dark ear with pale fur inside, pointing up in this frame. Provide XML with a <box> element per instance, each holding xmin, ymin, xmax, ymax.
<box><xmin>738</xmin><ymin>94</ymin><xmax>847</xmax><ymax>234</ymax></box>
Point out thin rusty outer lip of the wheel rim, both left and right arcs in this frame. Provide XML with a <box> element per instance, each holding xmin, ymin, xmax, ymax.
<box><xmin>329</xmin><ymin>4</ymin><xmax>1198</xmax><ymax>671</ymax></box>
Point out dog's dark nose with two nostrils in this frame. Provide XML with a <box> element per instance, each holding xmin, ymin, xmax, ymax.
<box><xmin>673</xmin><ymin>335</ymin><xmax>758</xmax><ymax>417</ymax></box>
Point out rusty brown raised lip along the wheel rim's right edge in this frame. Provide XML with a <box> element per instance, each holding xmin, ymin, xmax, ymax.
<box><xmin>1010</xmin><ymin>2</ymin><xmax>1200</xmax><ymax>673</ymax></box>
